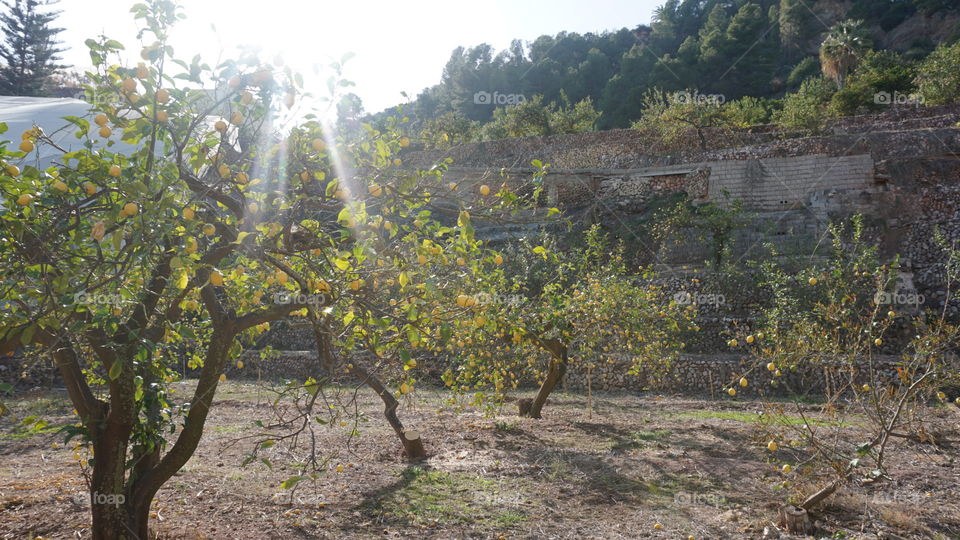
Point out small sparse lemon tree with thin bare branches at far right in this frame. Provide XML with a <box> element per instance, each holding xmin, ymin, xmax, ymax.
<box><xmin>730</xmin><ymin>217</ymin><xmax>960</xmax><ymax>510</ymax></box>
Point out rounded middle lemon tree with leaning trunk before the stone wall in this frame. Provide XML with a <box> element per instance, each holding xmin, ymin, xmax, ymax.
<box><xmin>443</xmin><ymin>226</ymin><xmax>695</xmax><ymax>418</ymax></box>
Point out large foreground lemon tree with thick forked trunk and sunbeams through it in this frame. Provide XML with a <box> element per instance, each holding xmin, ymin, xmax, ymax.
<box><xmin>0</xmin><ymin>0</ymin><xmax>516</xmax><ymax>538</ymax></box>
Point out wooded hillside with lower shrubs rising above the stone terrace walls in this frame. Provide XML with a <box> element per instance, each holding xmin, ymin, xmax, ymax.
<box><xmin>364</xmin><ymin>0</ymin><xmax>960</xmax><ymax>141</ymax></box>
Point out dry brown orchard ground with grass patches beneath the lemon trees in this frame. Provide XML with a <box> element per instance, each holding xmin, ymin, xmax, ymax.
<box><xmin>0</xmin><ymin>382</ymin><xmax>960</xmax><ymax>539</ymax></box>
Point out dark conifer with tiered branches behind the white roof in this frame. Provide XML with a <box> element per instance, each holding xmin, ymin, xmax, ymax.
<box><xmin>0</xmin><ymin>0</ymin><xmax>64</xmax><ymax>96</ymax></box>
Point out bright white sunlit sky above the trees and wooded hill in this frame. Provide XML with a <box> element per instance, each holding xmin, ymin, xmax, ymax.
<box><xmin>57</xmin><ymin>0</ymin><xmax>664</xmax><ymax>112</ymax></box>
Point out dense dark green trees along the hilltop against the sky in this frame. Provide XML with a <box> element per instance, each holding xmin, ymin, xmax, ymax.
<box><xmin>374</xmin><ymin>0</ymin><xmax>955</xmax><ymax>137</ymax></box>
